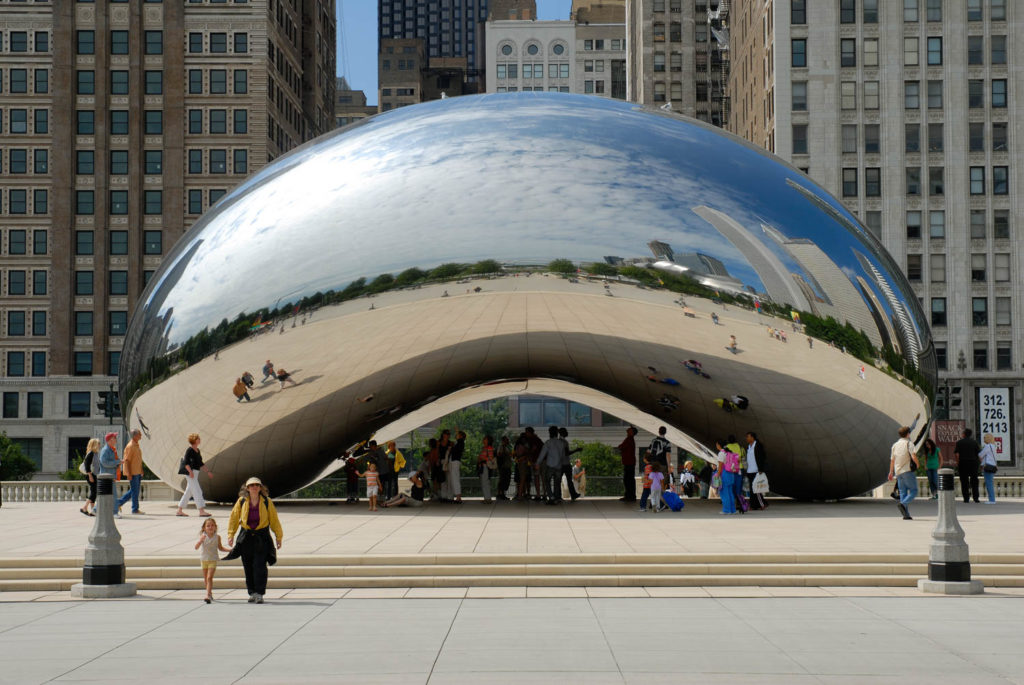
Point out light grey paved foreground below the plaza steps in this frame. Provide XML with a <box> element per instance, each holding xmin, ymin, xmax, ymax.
<box><xmin>0</xmin><ymin>594</ymin><xmax>1024</xmax><ymax>685</ymax></box>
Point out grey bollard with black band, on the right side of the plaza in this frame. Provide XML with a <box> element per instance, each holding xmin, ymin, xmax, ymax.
<box><xmin>918</xmin><ymin>469</ymin><xmax>985</xmax><ymax>595</ymax></box>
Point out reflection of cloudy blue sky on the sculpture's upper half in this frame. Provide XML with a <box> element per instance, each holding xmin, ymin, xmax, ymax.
<box><xmin>142</xmin><ymin>93</ymin><xmax>921</xmax><ymax>338</ymax></box>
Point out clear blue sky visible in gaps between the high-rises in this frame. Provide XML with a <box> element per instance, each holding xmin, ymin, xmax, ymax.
<box><xmin>338</xmin><ymin>0</ymin><xmax>572</xmax><ymax>104</ymax></box>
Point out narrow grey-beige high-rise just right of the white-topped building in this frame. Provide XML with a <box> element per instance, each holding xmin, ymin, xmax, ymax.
<box><xmin>626</xmin><ymin>0</ymin><xmax>730</xmax><ymax>126</ymax></box>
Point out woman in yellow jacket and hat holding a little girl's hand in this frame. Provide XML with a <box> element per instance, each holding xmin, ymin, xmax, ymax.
<box><xmin>224</xmin><ymin>476</ymin><xmax>285</xmax><ymax>604</ymax></box>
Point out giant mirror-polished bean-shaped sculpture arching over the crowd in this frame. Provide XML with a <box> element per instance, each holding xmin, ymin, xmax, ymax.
<box><xmin>120</xmin><ymin>93</ymin><xmax>935</xmax><ymax>500</ymax></box>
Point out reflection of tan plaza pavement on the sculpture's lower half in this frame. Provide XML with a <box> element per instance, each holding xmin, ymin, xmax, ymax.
<box><xmin>136</xmin><ymin>274</ymin><xmax>923</xmax><ymax>499</ymax></box>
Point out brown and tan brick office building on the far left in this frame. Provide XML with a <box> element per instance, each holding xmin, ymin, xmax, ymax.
<box><xmin>0</xmin><ymin>0</ymin><xmax>335</xmax><ymax>475</ymax></box>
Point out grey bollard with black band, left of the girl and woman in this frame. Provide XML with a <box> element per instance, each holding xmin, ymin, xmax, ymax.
<box><xmin>71</xmin><ymin>473</ymin><xmax>135</xmax><ymax>598</ymax></box>
